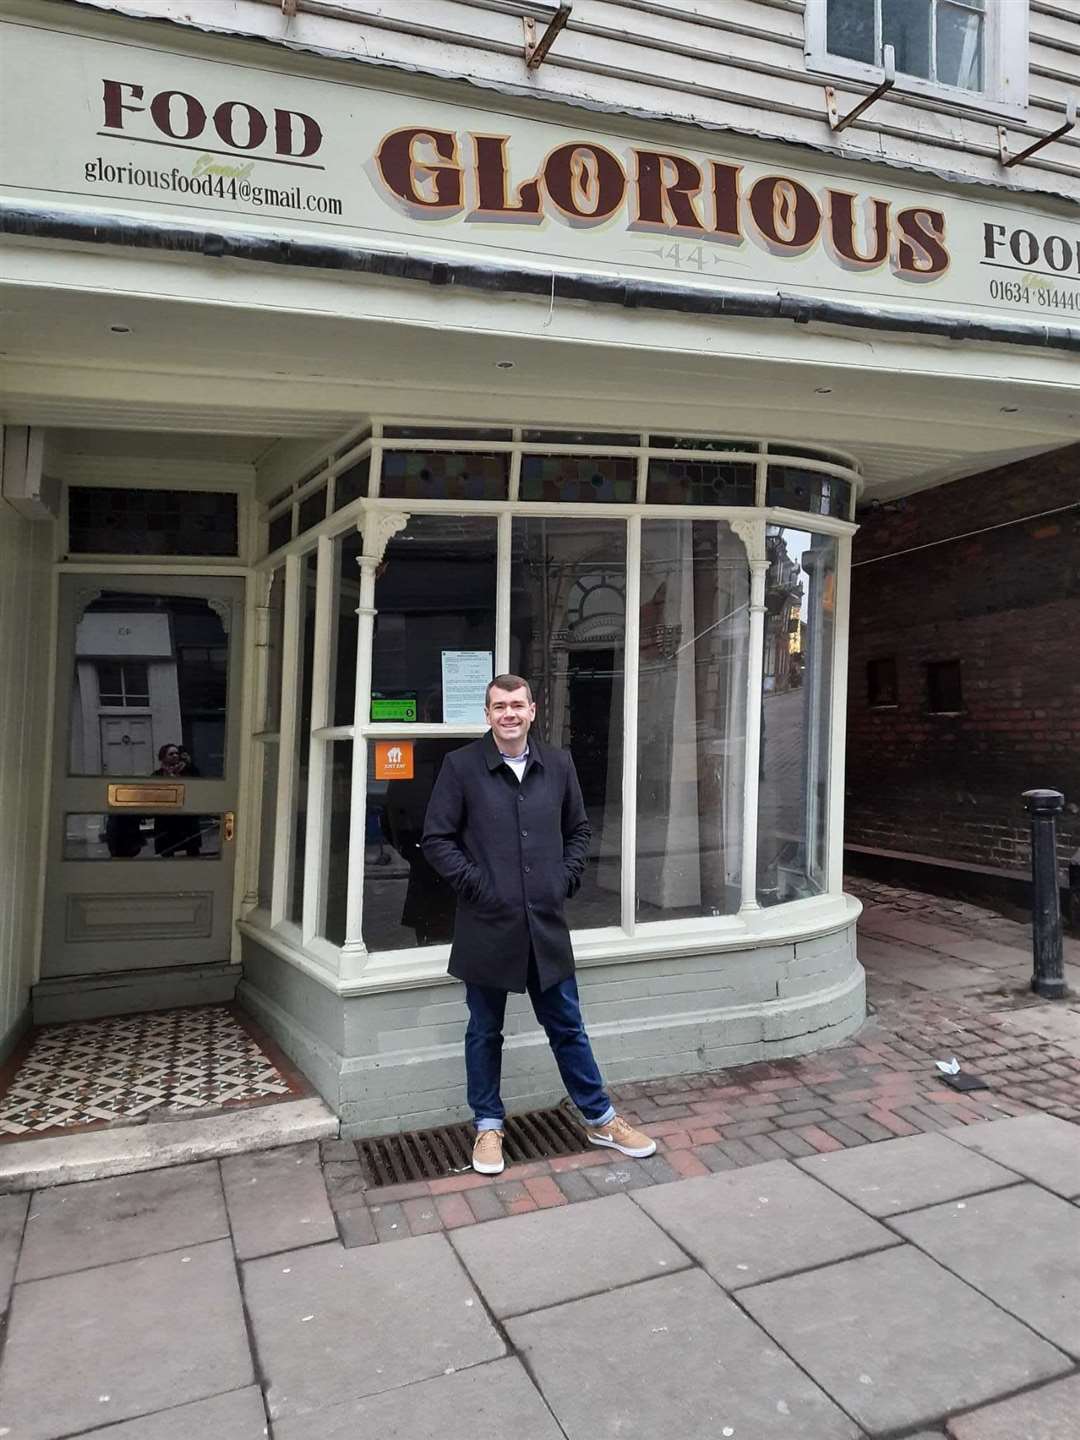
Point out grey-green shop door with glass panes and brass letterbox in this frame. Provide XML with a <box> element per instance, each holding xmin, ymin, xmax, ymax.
<box><xmin>42</xmin><ymin>576</ymin><xmax>243</xmax><ymax>978</ymax></box>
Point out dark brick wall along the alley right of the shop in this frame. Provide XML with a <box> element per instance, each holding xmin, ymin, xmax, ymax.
<box><xmin>845</xmin><ymin>445</ymin><xmax>1080</xmax><ymax>870</ymax></box>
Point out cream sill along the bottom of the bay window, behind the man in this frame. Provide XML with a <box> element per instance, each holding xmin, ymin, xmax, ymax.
<box><xmin>239</xmin><ymin>894</ymin><xmax>863</xmax><ymax>998</ymax></box>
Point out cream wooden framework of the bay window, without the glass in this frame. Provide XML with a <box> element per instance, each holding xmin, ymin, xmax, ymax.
<box><xmin>240</xmin><ymin>418</ymin><xmax>861</xmax><ymax>992</ymax></box>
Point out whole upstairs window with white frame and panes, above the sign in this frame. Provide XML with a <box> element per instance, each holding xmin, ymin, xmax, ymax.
<box><xmin>806</xmin><ymin>0</ymin><xmax>1028</xmax><ymax>111</ymax></box>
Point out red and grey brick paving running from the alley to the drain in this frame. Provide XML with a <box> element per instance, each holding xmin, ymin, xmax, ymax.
<box><xmin>323</xmin><ymin>881</ymin><xmax>1080</xmax><ymax>1246</ymax></box>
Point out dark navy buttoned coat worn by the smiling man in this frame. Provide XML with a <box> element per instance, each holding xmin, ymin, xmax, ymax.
<box><xmin>420</xmin><ymin>730</ymin><xmax>590</xmax><ymax>992</ymax></box>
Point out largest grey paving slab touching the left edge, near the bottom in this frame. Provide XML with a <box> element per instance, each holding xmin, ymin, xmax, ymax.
<box><xmin>0</xmin><ymin>1240</ymin><xmax>255</xmax><ymax>1440</ymax></box>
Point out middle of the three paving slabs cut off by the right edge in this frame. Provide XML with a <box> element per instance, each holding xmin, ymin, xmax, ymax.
<box><xmin>894</xmin><ymin>1185</ymin><xmax>1080</xmax><ymax>1359</ymax></box>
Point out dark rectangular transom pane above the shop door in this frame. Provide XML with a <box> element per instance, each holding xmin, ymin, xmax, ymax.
<box><xmin>68</xmin><ymin>485</ymin><xmax>239</xmax><ymax>556</ymax></box>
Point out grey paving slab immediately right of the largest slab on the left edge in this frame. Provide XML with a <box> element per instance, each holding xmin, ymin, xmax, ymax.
<box><xmin>243</xmin><ymin>1236</ymin><xmax>505</xmax><ymax>1426</ymax></box>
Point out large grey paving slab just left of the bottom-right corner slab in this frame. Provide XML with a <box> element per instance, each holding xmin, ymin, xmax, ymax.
<box><xmin>739</xmin><ymin>1246</ymin><xmax>1071</xmax><ymax>1436</ymax></box>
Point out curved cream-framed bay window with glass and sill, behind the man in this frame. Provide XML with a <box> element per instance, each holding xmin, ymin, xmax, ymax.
<box><xmin>248</xmin><ymin>425</ymin><xmax>857</xmax><ymax>976</ymax></box>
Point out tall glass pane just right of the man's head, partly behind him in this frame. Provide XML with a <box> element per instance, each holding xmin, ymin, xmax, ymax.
<box><xmin>510</xmin><ymin>516</ymin><xmax>626</xmax><ymax>929</ymax></box>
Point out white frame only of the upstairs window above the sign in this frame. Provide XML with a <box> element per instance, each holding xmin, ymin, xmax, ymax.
<box><xmin>804</xmin><ymin>0</ymin><xmax>1030</xmax><ymax>127</ymax></box>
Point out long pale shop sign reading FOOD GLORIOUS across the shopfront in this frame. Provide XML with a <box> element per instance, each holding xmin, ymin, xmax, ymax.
<box><xmin>0</xmin><ymin>23</ymin><xmax>1080</xmax><ymax>321</ymax></box>
